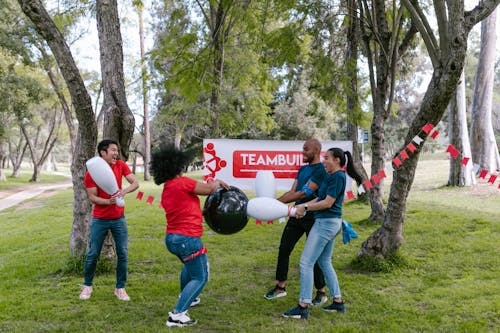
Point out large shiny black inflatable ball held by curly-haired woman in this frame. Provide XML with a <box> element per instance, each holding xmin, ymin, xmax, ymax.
<box><xmin>203</xmin><ymin>186</ymin><xmax>248</xmax><ymax>235</ymax></box>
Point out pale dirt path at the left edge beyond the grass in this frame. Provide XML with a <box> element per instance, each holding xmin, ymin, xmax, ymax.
<box><xmin>0</xmin><ymin>180</ymin><xmax>73</xmax><ymax>211</ymax></box>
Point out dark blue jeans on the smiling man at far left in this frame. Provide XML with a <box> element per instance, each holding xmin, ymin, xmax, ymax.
<box><xmin>83</xmin><ymin>216</ymin><xmax>128</xmax><ymax>288</ymax></box>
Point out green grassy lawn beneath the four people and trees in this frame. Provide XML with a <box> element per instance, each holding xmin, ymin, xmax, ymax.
<box><xmin>0</xmin><ymin>159</ymin><xmax>500</xmax><ymax>333</ymax></box>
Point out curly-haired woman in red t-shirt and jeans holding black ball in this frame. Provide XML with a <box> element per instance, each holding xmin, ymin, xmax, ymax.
<box><xmin>150</xmin><ymin>146</ymin><xmax>229</xmax><ymax>327</ymax></box>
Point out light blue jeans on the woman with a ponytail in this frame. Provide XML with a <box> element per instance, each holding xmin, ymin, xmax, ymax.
<box><xmin>299</xmin><ymin>218</ymin><xmax>342</xmax><ymax>304</ymax></box>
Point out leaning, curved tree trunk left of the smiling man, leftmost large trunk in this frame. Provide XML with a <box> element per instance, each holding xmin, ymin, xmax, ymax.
<box><xmin>18</xmin><ymin>0</ymin><xmax>97</xmax><ymax>256</ymax></box>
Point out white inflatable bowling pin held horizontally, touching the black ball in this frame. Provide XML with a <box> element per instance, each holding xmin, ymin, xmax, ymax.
<box><xmin>247</xmin><ymin>197</ymin><xmax>297</xmax><ymax>221</ymax></box>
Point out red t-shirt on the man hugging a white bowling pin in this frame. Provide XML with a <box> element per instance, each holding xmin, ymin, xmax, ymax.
<box><xmin>83</xmin><ymin>160</ymin><xmax>132</xmax><ymax>220</ymax></box>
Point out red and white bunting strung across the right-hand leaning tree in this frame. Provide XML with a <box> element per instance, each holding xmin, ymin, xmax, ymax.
<box><xmin>346</xmin><ymin>123</ymin><xmax>500</xmax><ymax>200</ymax></box>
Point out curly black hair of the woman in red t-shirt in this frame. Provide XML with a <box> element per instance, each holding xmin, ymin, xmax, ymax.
<box><xmin>149</xmin><ymin>145</ymin><xmax>192</xmax><ymax>185</ymax></box>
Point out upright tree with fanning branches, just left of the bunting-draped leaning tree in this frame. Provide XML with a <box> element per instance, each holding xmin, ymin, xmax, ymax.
<box><xmin>359</xmin><ymin>0</ymin><xmax>417</xmax><ymax>221</ymax></box>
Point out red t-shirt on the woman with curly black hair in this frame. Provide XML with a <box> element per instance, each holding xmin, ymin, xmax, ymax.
<box><xmin>161</xmin><ymin>176</ymin><xmax>203</xmax><ymax>237</ymax></box>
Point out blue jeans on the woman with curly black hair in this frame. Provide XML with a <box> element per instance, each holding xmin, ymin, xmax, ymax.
<box><xmin>165</xmin><ymin>234</ymin><xmax>208</xmax><ymax>312</ymax></box>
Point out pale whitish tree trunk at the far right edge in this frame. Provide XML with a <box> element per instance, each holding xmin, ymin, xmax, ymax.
<box><xmin>471</xmin><ymin>11</ymin><xmax>500</xmax><ymax>173</ymax></box>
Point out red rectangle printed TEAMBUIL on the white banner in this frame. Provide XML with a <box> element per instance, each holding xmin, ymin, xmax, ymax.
<box><xmin>233</xmin><ymin>150</ymin><xmax>303</xmax><ymax>178</ymax></box>
